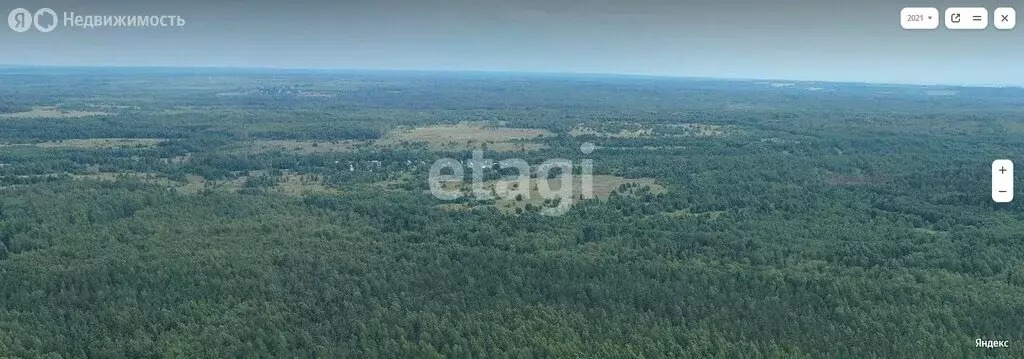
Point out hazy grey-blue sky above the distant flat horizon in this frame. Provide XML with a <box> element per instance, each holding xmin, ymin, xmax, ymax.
<box><xmin>0</xmin><ymin>0</ymin><xmax>1024</xmax><ymax>86</ymax></box>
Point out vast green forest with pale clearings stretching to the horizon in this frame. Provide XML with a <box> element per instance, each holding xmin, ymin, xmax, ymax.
<box><xmin>0</xmin><ymin>68</ymin><xmax>1024</xmax><ymax>358</ymax></box>
